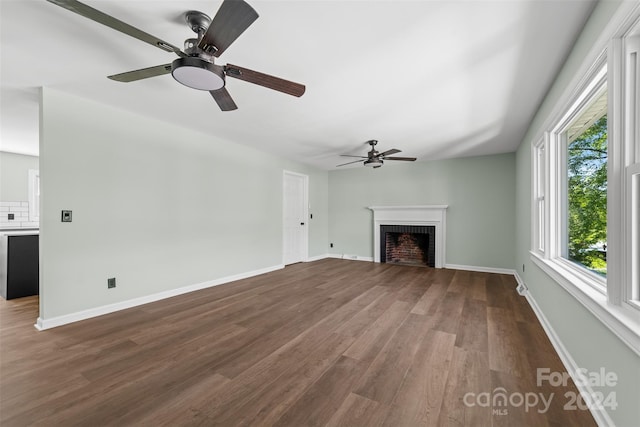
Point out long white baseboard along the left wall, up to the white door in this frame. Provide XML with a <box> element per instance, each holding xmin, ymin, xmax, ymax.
<box><xmin>34</xmin><ymin>264</ymin><xmax>284</xmax><ymax>331</ymax></box>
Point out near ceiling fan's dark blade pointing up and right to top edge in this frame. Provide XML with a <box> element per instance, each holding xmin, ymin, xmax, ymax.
<box><xmin>198</xmin><ymin>0</ymin><xmax>259</xmax><ymax>57</ymax></box>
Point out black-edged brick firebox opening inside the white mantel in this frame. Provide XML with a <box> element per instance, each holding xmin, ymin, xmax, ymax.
<box><xmin>380</xmin><ymin>225</ymin><xmax>436</xmax><ymax>267</ymax></box>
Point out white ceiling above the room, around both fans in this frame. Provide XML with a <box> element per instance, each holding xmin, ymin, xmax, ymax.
<box><xmin>0</xmin><ymin>0</ymin><xmax>594</xmax><ymax>169</ymax></box>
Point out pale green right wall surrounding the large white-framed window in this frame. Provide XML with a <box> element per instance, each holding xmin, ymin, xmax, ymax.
<box><xmin>516</xmin><ymin>1</ymin><xmax>640</xmax><ymax>426</ymax></box>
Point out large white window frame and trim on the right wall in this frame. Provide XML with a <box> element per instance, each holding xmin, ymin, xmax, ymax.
<box><xmin>530</xmin><ymin>2</ymin><xmax>640</xmax><ymax>355</ymax></box>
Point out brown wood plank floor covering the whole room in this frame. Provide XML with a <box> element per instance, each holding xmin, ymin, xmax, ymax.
<box><xmin>0</xmin><ymin>259</ymin><xmax>595</xmax><ymax>427</ymax></box>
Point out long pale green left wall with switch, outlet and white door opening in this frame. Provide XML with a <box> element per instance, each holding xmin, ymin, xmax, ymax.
<box><xmin>40</xmin><ymin>88</ymin><xmax>328</xmax><ymax>320</ymax></box>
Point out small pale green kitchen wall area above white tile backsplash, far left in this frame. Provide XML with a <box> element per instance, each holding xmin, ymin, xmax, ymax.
<box><xmin>0</xmin><ymin>151</ymin><xmax>39</xmax><ymax>202</ymax></box>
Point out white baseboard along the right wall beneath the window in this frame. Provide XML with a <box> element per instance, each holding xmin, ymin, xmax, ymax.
<box><xmin>515</xmin><ymin>280</ymin><xmax>615</xmax><ymax>426</ymax></box>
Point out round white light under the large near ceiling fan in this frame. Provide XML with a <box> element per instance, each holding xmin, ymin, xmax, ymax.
<box><xmin>171</xmin><ymin>56</ymin><xmax>224</xmax><ymax>91</ymax></box>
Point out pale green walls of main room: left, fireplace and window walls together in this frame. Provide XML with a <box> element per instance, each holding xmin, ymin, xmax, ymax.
<box><xmin>37</xmin><ymin>1</ymin><xmax>640</xmax><ymax>426</ymax></box>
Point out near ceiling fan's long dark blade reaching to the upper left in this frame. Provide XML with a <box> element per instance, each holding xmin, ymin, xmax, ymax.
<box><xmin>47</xmin><ymin>0</ymin><xmax>187</xmax><ymax>57</ymax></box>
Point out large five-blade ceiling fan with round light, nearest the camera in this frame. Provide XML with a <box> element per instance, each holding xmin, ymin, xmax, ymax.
<box><xmin>47</xmin><ymin>0</ymin><xmax>305</xmax><ymax>111</ymax></box>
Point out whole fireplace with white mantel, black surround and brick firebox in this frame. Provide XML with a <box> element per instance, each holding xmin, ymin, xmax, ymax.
<box><xmin>369</xmin><ymin>205</ymin><xmax>448</xmax><ymax>268</ymax></box>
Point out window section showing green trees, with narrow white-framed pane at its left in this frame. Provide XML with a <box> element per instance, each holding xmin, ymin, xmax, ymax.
<box><xmin>532</xmin><ymin>61</ymin><xmax>609</xmax><ymax>293</ymax></box>
